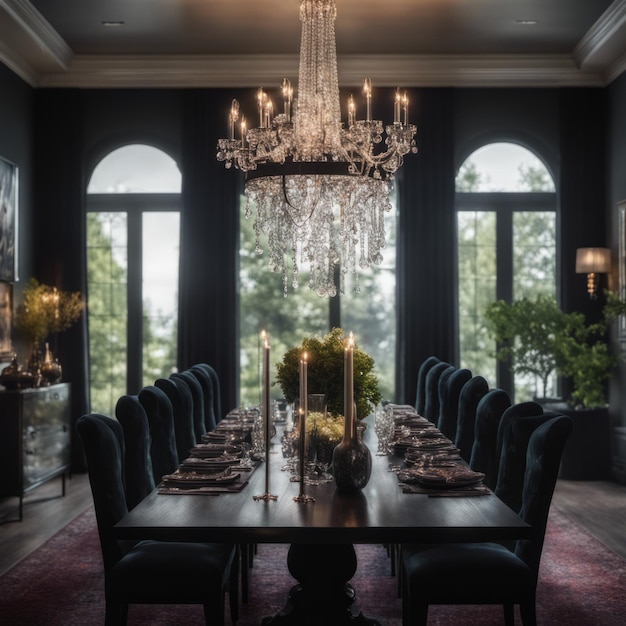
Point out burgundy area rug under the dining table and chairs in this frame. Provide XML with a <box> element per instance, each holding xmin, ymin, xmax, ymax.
<box><xmin>0</xmin><ymin>502</ymin><xmax>626</xmax><ymax>626</ymax></box>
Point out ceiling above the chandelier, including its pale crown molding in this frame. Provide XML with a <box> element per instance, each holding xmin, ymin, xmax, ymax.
<box><xmin>0</xmin><ymin>0</ymin><xmax>626</xmax><ymax>88</ymax></box>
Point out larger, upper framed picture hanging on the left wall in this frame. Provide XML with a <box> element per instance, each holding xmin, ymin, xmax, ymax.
<box><xmin>0</xmin><ymin>157</ymin><xmax>18</xmax><ymax>283</ymax></box>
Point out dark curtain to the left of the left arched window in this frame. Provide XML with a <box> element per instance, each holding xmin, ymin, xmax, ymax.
<box><xmin>33</xmin><ymin>89</ymin><xmax>89</xmax><ymax>471</ymax></box>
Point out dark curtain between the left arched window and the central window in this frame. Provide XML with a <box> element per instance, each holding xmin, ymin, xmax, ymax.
<box><xmin>178</xmin><ymin>89</ymin><xmax>242</xmax><ymax>410</ymax></box>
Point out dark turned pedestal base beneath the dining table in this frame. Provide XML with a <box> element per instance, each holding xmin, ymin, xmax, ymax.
<box><xmin>261</xmin><ymin>544</ymin><xmax>380</xmax><ymax>626</ymax></box>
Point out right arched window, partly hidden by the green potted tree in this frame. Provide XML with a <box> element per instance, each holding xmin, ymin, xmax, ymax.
<box><xmin>456</xmin><ymin>143</ymin><xmax>557</xmax><ymax>401</ymax></box>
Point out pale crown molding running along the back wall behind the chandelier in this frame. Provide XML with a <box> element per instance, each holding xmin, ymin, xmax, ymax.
<box><xmin>36</xmin><ymin>55</ymin><xmax>606</xmax><ymax>88</ymax></box>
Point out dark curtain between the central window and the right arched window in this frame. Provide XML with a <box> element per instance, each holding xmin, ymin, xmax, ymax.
<box><xmin>396</xmin><ymin>89</ymin><xmax>458</xmax><ymax>404</ymax></box>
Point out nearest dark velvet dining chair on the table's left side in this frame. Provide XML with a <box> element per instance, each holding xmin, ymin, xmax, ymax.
<box><xmin>76</xmin><ymin>413</ymin><xmax>236</xmax><ymax>626</ymax></box>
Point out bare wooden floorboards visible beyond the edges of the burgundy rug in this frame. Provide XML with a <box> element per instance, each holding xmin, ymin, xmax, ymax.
<box><xmin>0</xmin><ymin>474</ymin><xmax>626</xmax><ymax>575</ymax></box>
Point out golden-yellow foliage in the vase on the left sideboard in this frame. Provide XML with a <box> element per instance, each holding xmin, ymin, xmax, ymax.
<box><xmin>15</xmin><ymin>278</ymin><xmax>85</xmax><ymax>345</ymax></box>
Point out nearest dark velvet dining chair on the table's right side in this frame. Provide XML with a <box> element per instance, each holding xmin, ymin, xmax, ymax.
<box><xmin>402</xmin><ymin>415</ymin><xmax>572</xmax><ymax>626</ymax></box>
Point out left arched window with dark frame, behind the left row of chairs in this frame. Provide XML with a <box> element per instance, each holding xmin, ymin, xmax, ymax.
<box><xmin>87</xmin><ymin>144</ymin><xmax>181</xmax><ymax>415</ymax></box>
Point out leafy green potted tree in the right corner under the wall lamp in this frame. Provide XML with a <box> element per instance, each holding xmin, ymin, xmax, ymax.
<box><xmin>485</xmin><ymin>291</ymin><xmax>626</xmax><ymax>480</ymax></box>
